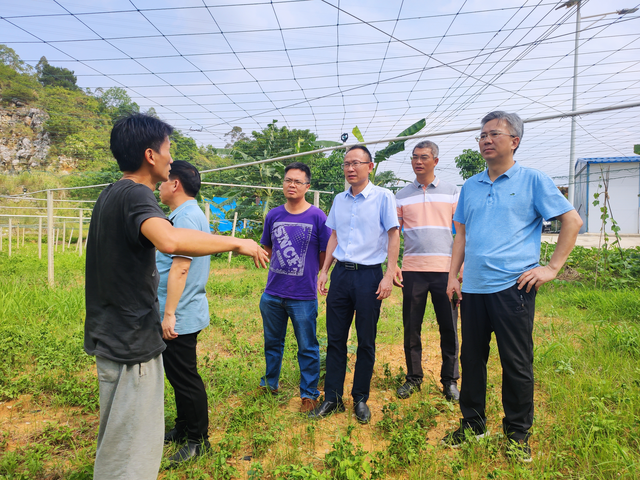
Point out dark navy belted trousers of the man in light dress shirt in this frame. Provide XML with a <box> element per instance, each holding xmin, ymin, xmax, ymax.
<box><xmin>324</xmin><ymin>263</ymin><xmax>382</xmax><ymax>404</ymax></box>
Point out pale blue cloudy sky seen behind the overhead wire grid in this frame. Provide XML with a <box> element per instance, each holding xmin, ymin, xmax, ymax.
<box><xmin>0</xmin><ymin>0</ymin><xmax>640</xmax><ymax>185</ymax></box>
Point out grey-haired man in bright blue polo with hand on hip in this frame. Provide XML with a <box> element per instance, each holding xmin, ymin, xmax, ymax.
<box><xmin>442</xmin><ymin>111</ymin><xmax>582</xmax><ymax>462</ymax></box>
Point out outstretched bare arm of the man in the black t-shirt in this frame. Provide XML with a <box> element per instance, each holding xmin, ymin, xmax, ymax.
<box><xmin>140</xmin><ymin>217</ymin><xmax>269</xmax><ymax>268</ymax></box>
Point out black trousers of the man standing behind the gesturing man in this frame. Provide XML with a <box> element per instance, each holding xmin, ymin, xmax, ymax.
<box><xmin>162</xmin><ymin>332</ymin><xmax>209</xmax><ymax>442</ymax></box>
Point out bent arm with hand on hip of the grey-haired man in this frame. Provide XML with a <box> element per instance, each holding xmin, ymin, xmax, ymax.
<box><xmin>518</xmin><ymin>210</ymin><xmax>582</xmax><ymax>293</ymax></box>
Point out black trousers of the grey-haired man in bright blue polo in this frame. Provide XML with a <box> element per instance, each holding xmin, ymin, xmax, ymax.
<box><xmin>460</xmin><ymin>285</ymin><xmax>536</xmax><ymax>440</ymax></box>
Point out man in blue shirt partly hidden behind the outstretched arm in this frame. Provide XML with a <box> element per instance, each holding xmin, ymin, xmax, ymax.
<box><xmin>156</xmin><ymin>160</ymin><xmax>211</xmax><ymax>463</ymax></box>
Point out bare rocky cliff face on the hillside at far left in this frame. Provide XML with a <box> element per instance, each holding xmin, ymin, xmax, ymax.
<box><xmin>0</xmin><ymin>103</ymin><xmax>52</xmax><ymax>173</ymax></box>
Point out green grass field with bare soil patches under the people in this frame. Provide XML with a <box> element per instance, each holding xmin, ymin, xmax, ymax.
<box><xmin>0</xmin><ymin>243</ymin><xmax>640</xmax><ymax>479</ymax></box>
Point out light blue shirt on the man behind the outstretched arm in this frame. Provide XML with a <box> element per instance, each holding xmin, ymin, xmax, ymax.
<box><xmin>156</xmin><ymin>200</ymin><xmax>210</xmax><ymax>335</ymax></box>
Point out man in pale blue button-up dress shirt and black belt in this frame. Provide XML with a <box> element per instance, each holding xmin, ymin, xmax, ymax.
<box><xmin>309</xmin><ymin>145</ymin><xmax>400</xmax><ymax>423</ymax></box>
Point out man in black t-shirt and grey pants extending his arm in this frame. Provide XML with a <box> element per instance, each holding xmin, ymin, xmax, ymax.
<box><xmin>84</xmin><ymin>114</ymin><xmax>267</xmax><ymax>480</ymax></box>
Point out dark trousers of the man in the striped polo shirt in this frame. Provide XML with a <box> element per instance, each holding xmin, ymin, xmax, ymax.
<box><xmin>402</xmin><ymin>272</ymin><xmax>460</xmax><ymax>385</ymax></box>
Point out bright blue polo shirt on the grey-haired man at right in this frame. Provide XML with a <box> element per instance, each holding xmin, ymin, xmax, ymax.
<box><xmin>453</xmin><ymin>162</ymin><xmax>573</xmax><ymax>293</ymax></box>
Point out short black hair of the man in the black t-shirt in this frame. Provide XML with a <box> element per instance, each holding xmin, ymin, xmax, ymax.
<box><xmin>110</xmin><ymin>113</ymin><xmax>173</xmax><ymax>172</ymax></box>
